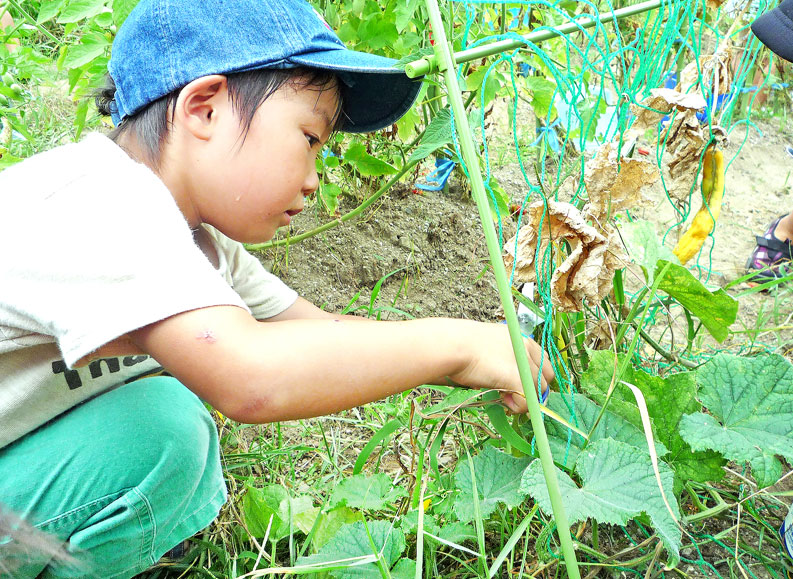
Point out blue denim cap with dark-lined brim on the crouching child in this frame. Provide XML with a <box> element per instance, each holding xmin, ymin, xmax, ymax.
<box><xmin>108</xmin><ymin>0</ymin><xmax>421</xmax><ymax>133</ymax></box>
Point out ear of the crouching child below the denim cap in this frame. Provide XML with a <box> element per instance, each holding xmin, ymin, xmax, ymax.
<box><xmin>173</xmin><ymin>74</ymin><xmax>228</xmax><ymax>140</ymax></box>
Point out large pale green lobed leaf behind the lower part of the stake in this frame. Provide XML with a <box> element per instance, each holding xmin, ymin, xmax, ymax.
<box><xmin>520</xmin><ymin>438</ymin><xmax>682</xmax><ymax>559</ymax></box>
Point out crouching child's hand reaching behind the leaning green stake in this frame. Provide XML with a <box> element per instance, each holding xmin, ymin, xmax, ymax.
<box><xmin>449</xmin><ymin>323</ymin><xmax>556</xmax><ymax>413</ymax></box>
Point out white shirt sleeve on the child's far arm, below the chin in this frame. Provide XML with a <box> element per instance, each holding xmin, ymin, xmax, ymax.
<box><xmin>207</xmin><ymin>227</ymin><xmax>297</xmax><ymax>320</ymax></box>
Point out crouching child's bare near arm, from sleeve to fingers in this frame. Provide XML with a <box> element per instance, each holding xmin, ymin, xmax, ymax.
<box><xmin>131</xmin><ymin>306</ymin><xmax>553</xmax><ymax>423</ymax></box>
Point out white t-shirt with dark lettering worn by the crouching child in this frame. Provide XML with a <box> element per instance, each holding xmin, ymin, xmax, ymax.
<box><xmin>0</xmin><ymin>134</ymin><xmax>297</xmax><ymax>448</ymax></box>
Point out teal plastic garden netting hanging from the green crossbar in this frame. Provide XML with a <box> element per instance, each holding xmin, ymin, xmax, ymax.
<box><xmin>440</xmin><ymin>0</ymin><xmax>776</xmax><ymax>394</ymax></box>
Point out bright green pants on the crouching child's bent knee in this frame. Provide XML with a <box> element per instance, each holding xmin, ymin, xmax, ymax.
<box><xmin>0</xmin><ymin>377</ymin><xmax>226</xmax><ymax>579</ymax></box>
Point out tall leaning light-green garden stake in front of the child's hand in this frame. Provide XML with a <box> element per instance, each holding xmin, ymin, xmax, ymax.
<box><xmin>426</xmin><ymin>0</ymin><xmax>581</xmax><ymax>579</ymax></box>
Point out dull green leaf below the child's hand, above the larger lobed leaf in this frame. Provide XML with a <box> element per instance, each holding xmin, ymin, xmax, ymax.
<box><xmin>545</xmin><ymin>392</ymin><xmax>667</xmax><ymax>467</ymax></box>
